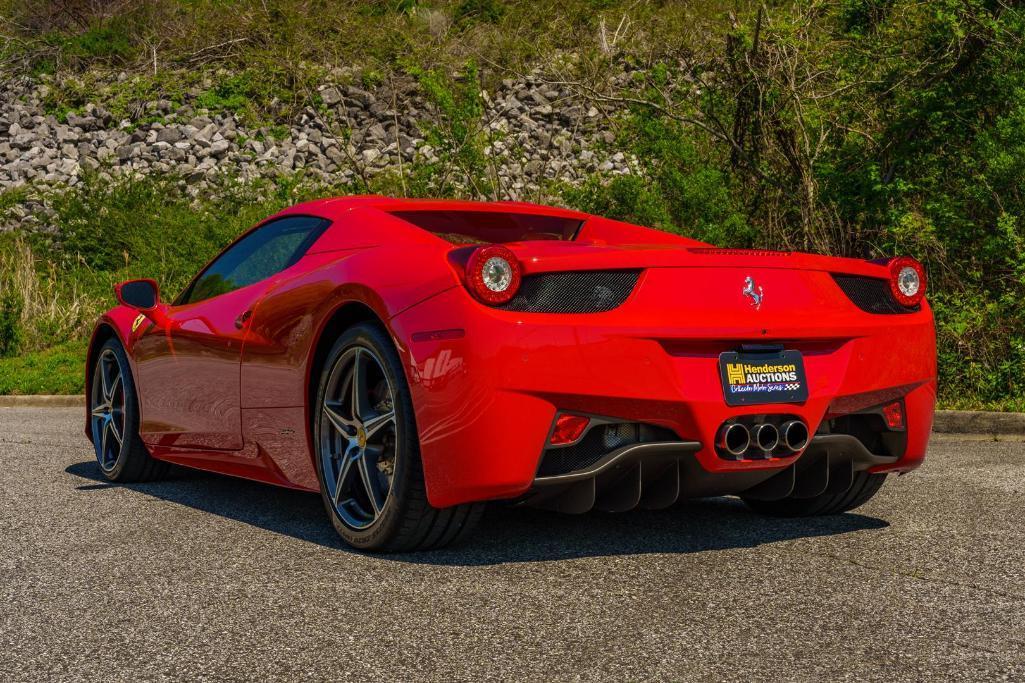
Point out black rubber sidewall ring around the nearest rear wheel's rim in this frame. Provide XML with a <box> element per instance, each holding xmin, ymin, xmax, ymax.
<box><xmin>312</xmin><ymin>323</ymin><xmax>420</xmax><ymax>550</ymax></box>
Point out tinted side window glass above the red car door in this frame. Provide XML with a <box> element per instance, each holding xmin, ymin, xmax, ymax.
<box><xmin>177</xmin><ymin>215</ymin><xmax>330</xmax><ymax>305</ymax></box>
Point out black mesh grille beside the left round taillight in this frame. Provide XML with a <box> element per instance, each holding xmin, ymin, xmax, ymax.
<box><xmin>499</xmin><ymin>271</ymin><xmax>641</xmax><ymax>313</ymax></box>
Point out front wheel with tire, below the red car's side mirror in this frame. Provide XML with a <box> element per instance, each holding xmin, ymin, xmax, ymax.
<box><xmin>89</xmin><ymin>338</ymin><xmax>171</xmax><ymax>483</ymax></box>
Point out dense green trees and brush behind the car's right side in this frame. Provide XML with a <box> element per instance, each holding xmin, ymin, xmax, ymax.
<box><xmin>570</xmin><ymin>0</ymin><xmax>1025</xmax><ymax>403</ymax></box>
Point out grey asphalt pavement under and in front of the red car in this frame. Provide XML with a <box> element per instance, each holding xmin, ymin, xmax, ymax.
<box><xmin>0</xmin><ymin>408</ymin><xmax>1025</xmax><ymax>681</ymax></box>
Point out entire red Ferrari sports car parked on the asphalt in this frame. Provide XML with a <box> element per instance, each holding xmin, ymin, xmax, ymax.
<box><xmin>86</xmin><ymin>197</ymin><xmax>936</xmax><ymax>551</ymax></box>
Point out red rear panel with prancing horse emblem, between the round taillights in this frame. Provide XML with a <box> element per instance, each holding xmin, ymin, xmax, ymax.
<box><xmin>496</xmin><ymin>241</ymin><xmax>921</xmax><ymax>340</ymax></box>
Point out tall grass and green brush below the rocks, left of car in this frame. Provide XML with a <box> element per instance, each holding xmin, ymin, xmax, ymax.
<box><xmin>0</xmin><ymin>170</ymin><xmax>356</xmax><ymax>357</ymax></box>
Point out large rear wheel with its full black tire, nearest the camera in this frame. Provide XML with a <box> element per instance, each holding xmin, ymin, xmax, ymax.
<box><xmin>313</xmin><ymin>323</ymin><xmax>483</xmax><ymax>552</ymax></box>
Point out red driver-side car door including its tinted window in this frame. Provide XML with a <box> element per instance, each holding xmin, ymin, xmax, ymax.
<box><xmin>133</xmin><ymin>215</ymin><xmax>329</xmax><ymax>451</ymax></box>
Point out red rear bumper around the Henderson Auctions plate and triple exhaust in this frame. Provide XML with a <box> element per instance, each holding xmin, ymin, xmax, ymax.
<box><xmin>392</xmin><ymin>280</ymin><xmax>936</xmax><ymax>507</ymax></box>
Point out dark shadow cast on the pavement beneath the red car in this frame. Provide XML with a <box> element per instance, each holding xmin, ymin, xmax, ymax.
<box><xmin>66</xmin><ymin>460</ymin><xmax>890</xmax><ymax>566</ymax></box>
